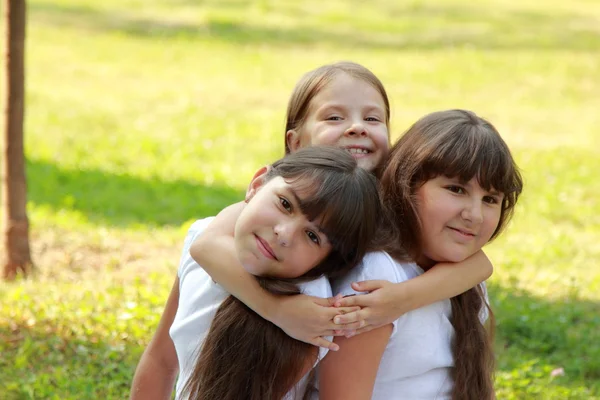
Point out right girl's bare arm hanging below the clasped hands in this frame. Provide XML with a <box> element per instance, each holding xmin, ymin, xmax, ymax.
<box><xmin>319</xmin><ymin>324</ymin><xmax>392</xmax><ymax>400</ymax></box>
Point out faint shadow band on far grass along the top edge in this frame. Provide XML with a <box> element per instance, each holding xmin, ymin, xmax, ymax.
<box><xmin>30</xmin><ymin>1</ymin><xmax>600</xmax><ymax>51</ymax></box>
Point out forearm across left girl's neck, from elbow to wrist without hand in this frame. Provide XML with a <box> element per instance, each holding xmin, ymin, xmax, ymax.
<box><xmin>190</xmin><ymin>235</ymin><xmax>277</xmax><ymax>320</ymax></box>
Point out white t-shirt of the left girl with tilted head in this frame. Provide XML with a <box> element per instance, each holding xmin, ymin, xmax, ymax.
<box><xmin>169</xmin><ymin>217</ymin><xmax>331</xmax><ymax>400</ymax></box>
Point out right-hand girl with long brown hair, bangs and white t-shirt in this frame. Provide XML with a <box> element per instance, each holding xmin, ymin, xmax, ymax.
<box><xmin>319</xmin><ymin>110</ymin><xmax>523</xmax><ymax>400</ymax></box>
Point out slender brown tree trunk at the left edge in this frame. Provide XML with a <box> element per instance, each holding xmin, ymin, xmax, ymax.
<box><xmin>2</xmin><ymin>0</ymin><xmax>33</xmax><ymax>279</ymax></box>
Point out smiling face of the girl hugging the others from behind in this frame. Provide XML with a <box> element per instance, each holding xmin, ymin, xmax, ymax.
<box><xmin>286</xmin><ymin>73</ymin><xmax>389</xmax><ymax>171</ymax></box>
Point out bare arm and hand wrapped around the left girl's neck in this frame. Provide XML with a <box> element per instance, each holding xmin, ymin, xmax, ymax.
<box><xmin>190</xmin><ymin>204</ymin><xmax>357</xmax><ymax>350</ymax></box>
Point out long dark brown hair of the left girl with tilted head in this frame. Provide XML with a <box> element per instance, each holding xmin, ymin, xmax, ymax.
<box><xmin>182</xmin><ymin>146</ymin><xmax>380</xmax><ymax>400</ymax></box>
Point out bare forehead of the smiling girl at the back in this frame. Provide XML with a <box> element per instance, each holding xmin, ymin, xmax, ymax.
<box><xmin>310</xmin><ymin>72</ymin><xmax>385</xmax><ymax>109</ymax></box>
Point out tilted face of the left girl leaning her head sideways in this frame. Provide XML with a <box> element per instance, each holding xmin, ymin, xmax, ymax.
<box><xmin>234</xmin><ymin>169</ymin><xmax>332</xmax><ymax>278</ymax></box>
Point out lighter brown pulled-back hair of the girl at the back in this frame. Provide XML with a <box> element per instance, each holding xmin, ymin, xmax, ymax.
<box><xmin>284</xmin><ymin>61</ymin><xmax>390</xmax><ymax>154</ymax></box>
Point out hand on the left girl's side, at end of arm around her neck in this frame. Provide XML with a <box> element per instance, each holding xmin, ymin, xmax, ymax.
<box><xmin>271</xmin><ymin>294</ymin><xmax>360</xmax><ymax>351</ymax></box>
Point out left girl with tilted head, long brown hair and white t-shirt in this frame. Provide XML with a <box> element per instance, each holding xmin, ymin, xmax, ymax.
<box><xmin>131</xmin><ymin>147</ymin><xmax>380</xmax><ymax>400</ymax></box>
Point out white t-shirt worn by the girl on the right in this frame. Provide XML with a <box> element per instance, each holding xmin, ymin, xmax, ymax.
<box><xmin>333</xmin><ymin>252</ymin><xmax>454</xmax><ymax>400</ymax></box>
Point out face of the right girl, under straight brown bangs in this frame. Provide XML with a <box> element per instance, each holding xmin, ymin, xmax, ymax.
<box><xmin>416</xmin><ymin>175</ymin><xmax>504</xmax><ymax>268</ymax></box>
